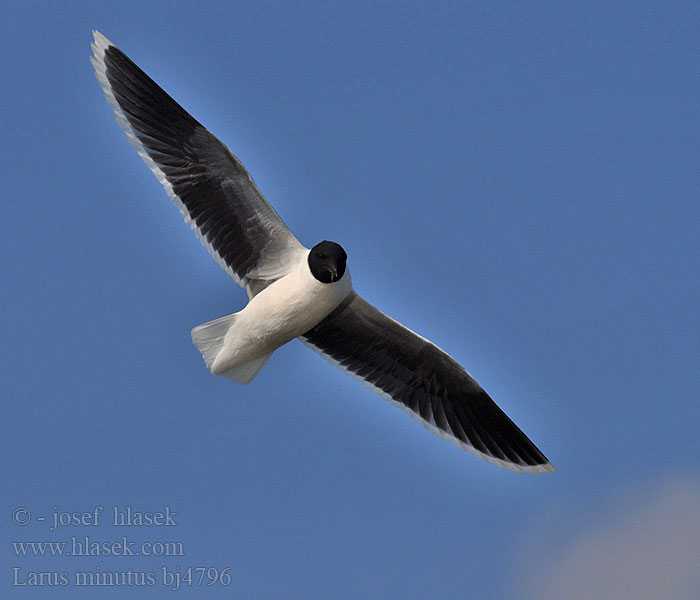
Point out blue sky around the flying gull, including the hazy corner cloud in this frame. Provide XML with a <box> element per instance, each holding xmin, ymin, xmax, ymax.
<box><xmin>0</xmin><ymin>2</ymin><xmax>700</xmax><ymax>599</ymax></box>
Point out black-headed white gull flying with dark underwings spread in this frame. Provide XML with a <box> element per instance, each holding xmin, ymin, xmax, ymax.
<box><xmin>91</xmin><ymin>31</ymin><xmax>554</xmax><ymax>473</ymax></box>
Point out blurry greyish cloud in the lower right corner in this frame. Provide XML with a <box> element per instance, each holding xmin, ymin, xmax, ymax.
<box><xmin>522</xmin><ymin>480</ymin><xmax>700</xmax><ymax>600</ymax></box>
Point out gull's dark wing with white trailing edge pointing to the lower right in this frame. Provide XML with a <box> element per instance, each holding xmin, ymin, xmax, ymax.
<box><xmin>300</xmin><ymin>293</ymin><xmax>554</xmax><ymax>473</ymax></box>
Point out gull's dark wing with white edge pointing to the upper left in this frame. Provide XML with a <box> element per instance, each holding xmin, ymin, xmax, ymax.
<box><xmin>91</xmin><ymin>31</ymin><xmax>304</xmax><ymax>297</ymax></box>
